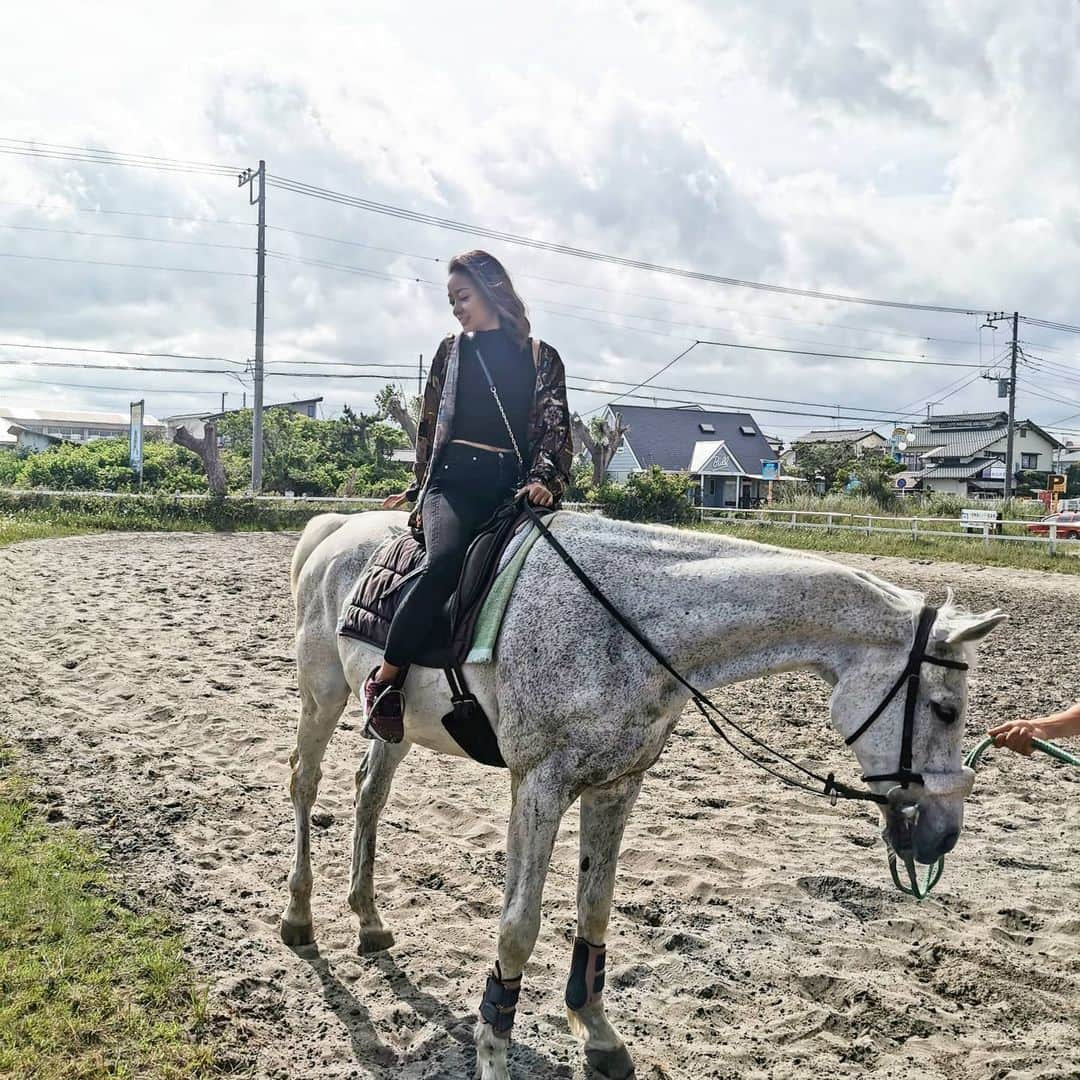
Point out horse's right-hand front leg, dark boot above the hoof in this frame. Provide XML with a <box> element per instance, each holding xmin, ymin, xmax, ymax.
<box><xmin>566</xmin><ymin>773</ymin><xmax>642</xmax><ymax>1080</ymax></box>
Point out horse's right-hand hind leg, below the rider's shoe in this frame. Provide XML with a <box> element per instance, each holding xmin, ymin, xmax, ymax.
<box><xmin>349</xmin><ymin>742</ymin><xmax>411</xmax><ymax>955</ymax></box>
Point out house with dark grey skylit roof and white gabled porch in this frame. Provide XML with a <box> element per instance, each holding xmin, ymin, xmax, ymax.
<box><xmin>604</xmin><ymin>404</ymin><xmax>777</xmax><ymax>507</ymax></box>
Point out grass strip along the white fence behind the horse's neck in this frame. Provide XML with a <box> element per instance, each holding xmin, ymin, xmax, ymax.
<box><xmin>694</xmin><ymin>522</ymin><xmax>1080</xmax><ymax>573</ymax></box>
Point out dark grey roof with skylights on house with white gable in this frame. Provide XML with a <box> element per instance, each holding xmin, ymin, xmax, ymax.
<box><xmin>608</xmin><ymin>403</ymin><xmax>777</xmax><ymax>476</ymax></box>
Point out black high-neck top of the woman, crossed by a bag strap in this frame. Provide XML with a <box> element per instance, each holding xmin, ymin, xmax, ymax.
<box><xmin>450</xmin><ymin>328</ymin><xmax>536</xmax><ymax>451</ymax></box>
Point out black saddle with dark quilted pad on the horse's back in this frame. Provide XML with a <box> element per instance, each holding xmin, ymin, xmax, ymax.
<box><xmin>338</xmin><ymin>502</ymin><xmax>529</xmax><ymax>767</ymax></box>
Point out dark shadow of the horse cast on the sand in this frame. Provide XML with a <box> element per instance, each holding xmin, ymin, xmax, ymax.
<box><xmin>293</xmin><ymin>945</ymin><xmax>569</xmax><ymax>1080</ymax></box>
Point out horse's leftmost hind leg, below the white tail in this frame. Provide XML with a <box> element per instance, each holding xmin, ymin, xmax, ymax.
<box><xmin>281</xmin><ymin>665</ymin><xmax>349</xmax><ymax>947</ymax></box>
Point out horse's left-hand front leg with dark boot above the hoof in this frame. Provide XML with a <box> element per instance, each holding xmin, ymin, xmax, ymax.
<box><xmin>473</xmin><ymin>767</ymin><xmax>572</xmax><ymax>1080</ymax></box>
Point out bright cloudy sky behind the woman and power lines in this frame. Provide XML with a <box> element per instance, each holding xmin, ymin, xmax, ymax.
<box><xmin>0</xmin><ymin>0</ymin><xmax>1080</xmax><ymax>437</ymax></box>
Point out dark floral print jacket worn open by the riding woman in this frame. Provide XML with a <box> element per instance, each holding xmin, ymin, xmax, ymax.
<box><xmin>406</xmin><ymin>334</ymin><xmax>573</xmax><ymax>528</ymax></box>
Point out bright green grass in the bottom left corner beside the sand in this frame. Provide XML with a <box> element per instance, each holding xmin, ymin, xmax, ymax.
<box><xmin>0</xmin><ymin>748</ymin><xmax>245</xmax><ymax>1080</ymax></box>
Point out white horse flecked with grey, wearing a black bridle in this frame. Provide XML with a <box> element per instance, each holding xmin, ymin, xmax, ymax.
<box><xmin>281</xmin><ymin>511</ymin><xmax>1005</xmax><ymax>1080</ymax></box>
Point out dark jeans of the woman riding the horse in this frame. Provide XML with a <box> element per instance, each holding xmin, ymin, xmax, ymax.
<box><xmin>383</xmin><ymin>443</ymin><xmax>517</xmax><ymax>667</ymax></box>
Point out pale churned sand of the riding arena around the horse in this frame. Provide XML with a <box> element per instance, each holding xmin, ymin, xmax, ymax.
<box><xmin>0</xmin><ymin>535</ymin><xmax>1080</xmax><ymax>1080</ymax></box>
